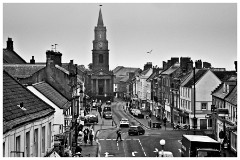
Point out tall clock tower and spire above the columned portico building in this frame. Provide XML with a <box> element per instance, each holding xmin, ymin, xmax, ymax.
<box><xmin>92</xmin><ymin>8</ymin><xmax>109</xmax><ymax>71</ymax></box>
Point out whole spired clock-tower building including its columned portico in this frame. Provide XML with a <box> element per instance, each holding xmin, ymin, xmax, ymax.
<box><xmin>86</xmin><ymin>8</ymin><xmax>114</xmax><ymax>102</ymax></box>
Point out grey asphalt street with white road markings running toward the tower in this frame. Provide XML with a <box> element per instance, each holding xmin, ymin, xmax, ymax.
<box><xmin>98</xmin><ymin>102</ymin><xmax>184</xmax><ymax>157</ymax></box>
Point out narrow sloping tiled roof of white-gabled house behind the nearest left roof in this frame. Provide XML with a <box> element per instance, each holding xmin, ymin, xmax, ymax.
<box><xmin>32</xmin><ymin>82</ymin><xmax>71</xmax><ymax>110</ymax></box>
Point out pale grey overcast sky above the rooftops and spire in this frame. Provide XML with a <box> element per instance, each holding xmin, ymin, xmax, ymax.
<box><xmin>3</xmin><ymin>3</ymin><xmax>237</xmax><ymax>70</ymax></box>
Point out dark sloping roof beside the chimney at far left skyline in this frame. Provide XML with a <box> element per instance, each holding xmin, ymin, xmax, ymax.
<box><xmin>3</xmin><ymin>49</ymin><xmax>27</xmax><ymax>64</ymax></box>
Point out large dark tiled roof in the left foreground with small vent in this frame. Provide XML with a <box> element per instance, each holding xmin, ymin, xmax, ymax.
<box><xmin>3</xmin><ymin>71</ymin><xmax>55</xmax><ymax>133</ymax></box>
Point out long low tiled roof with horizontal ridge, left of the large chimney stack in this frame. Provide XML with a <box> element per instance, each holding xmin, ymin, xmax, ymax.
<box><xmin>3</xmin><ymin>64</ymin><xmax>46</xmax><ymax>78</ymax></box>
